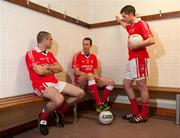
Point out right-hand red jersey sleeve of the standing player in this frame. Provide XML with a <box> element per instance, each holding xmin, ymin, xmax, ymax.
<box><xmin>140</xmin><ymin>21</ymin><xmax>152</xmax><ymax>39</ymax></box>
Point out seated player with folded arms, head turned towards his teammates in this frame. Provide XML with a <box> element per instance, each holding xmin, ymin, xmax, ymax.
<box><xmin>25</xmin><ymin>31</ymin><xmax>85</xmax><ymax>135</ymax></box>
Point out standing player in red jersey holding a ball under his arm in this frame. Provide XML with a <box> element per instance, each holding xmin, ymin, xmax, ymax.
<box><xmin>116</xmin><ymin>5</ymin><xmax>154</xmax><ymax>123</ymax></box>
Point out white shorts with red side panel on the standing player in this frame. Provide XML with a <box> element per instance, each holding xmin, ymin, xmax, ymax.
<box><xmin>124</xmin><ymin>58</ymin><xmax>149</xmax><ymax>80</ymax></box>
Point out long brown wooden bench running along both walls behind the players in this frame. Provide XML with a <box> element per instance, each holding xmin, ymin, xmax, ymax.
<box><xmin>0</xmin><ymin>85</ymin><xmax>180</xmax><ymax>133</ymax></box>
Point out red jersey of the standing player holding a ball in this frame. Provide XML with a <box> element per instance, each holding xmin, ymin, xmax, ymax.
<box><xmin>126</xmin><ymin>18</ymin><xmax>152</xmax><ymax>60</ymax></box>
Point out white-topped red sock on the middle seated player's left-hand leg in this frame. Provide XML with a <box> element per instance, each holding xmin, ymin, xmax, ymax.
<box><xmin>88</xmin><ymin>80</ymin><xmax>101</xmax><ymax>106</ymax></box>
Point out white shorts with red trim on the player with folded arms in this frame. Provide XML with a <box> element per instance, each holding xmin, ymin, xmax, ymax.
<box><xmin>34</xmin><ymin>81</ymin><xmax>66</xmax><ymax>96</ymax></box>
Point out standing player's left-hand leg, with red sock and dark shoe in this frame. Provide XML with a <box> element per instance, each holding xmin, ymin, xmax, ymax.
<box><xmin>123</xmin><ymin>79</ymin><xmax>139</xmax><ymax>119</ymax></box>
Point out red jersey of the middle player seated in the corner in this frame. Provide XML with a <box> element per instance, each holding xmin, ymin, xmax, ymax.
<box><xmin>72</xmin><ymin>51</ymin><xmax>98</xmax><ymax>76</ymax></box>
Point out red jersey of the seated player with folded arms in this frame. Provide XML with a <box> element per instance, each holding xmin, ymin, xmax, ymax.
<box><xmin>25</xmin><ymin>47</ymin><xmax>58</xmax><ymax>87</ymax></box>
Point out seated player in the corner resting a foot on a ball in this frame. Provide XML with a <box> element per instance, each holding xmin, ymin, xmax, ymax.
<box><xmin>72</xmin><ymin>37</ymin><xmax>114</xmax><ymax>113</ymax></box>
